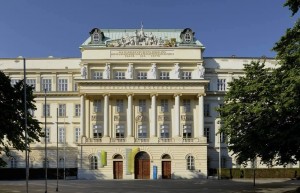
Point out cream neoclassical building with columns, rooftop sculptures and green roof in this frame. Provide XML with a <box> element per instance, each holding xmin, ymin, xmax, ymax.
<box><xmin>0</xmin><ymin>28</ymin><xmax>286</xmax><ymax>179</ymax></box>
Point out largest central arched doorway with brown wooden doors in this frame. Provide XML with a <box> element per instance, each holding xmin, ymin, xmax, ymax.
<box><xmin>134</xmin><ymin>151</ymin><xmax>150</xmax><ymax>179</ymax></box>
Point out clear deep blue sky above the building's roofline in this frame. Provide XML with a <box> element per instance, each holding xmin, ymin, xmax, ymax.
<box><xmin>0</xmin><ymin>0</ymin><xmax>299</xmax><ymax>58</ymax></box>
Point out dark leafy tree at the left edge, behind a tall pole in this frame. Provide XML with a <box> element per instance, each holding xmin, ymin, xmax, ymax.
<box><xmin>0</xmin><ymin>71</ymin><xmax>43</xmax><ymax>166</ymax></box>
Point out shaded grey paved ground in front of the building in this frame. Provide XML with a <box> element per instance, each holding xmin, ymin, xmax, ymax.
<box><xmin>0</xmin><ymin>179</ymin><xmax>300</xmax><ymax>193</ymax></box>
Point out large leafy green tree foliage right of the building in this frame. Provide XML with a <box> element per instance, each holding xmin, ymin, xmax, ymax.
<box><xmin>218</xmin><ymin>0</ymin><xmax>300</xmax><ymax>165</ymax></box>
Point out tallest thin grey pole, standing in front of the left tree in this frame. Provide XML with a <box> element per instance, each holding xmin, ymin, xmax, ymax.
<box><xmin>23</xmin><ymin>58</ymin><xmax>29</xmax><ymax>193</ymax></box>
